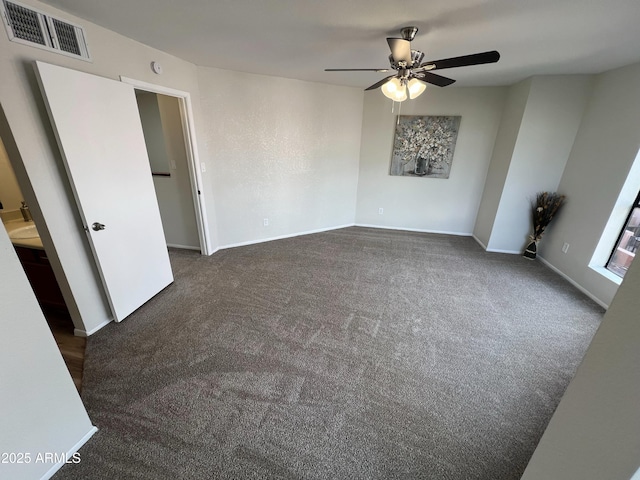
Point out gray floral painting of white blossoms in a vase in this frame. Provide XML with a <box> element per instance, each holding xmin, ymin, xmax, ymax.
<box><xmin>390</xmin><ymin>115</ymin><xmax>461</xmax><ymax>178</ymax></box>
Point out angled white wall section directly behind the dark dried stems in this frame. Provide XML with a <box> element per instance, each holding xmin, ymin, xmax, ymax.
<box><xmin>487</xmin><ymin>75</ymin><xmax>591</xmax><ymax>253</ymax></box>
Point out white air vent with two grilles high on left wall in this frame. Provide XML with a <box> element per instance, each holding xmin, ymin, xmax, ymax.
<box><xmin>0</xmin><ymin>0</ymin><xmax>91</xmax><ymax>61</ymax></box>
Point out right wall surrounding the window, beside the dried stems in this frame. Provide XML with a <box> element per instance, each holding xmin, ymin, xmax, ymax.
<box><xmin>539</xmin><ymin>64</ymin><xmax>640</xmax><ymax>304</ymax></box>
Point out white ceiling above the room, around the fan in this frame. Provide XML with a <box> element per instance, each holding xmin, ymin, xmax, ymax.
<box><xmin>45</xmin><ymin>0</ymin><xmax>640</xmax><ymax>88</ymax></box>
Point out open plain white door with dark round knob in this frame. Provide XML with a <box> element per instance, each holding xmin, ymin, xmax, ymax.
<box><xmin>36</xmin><ymin>62</ymin><xmax>173</xmax><ymax>322</ymax></box>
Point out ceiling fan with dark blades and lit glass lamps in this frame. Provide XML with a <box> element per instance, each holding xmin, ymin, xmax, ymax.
<box><xmin>325</xmin><ymin>27</ymin><xmax>500</xmax><ymax>102</ymax></box>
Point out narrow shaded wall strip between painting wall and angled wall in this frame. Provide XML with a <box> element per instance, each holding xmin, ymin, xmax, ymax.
<box><xmin>473</xmin><ymin>79</ymin><xmax>531</xmax><ymax>248</ymax></box>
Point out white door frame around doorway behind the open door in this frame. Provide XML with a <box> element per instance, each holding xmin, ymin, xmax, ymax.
<box><xmin>120</xmin><ymin>75</ymin><xmax>214</xmax><ymax>255</ymax></box>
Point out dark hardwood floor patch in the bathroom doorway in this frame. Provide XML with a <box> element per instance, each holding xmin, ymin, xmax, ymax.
<box><xmin>44</xmin><ymin>310</ymin><xmax>87</xmax><ymax>392</ymax></box>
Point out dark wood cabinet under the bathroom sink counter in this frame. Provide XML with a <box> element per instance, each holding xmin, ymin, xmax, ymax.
<box><xmin>15</xmin><ymin>247</ymin><xmax>67</xmax><ymax>312</ymax></box>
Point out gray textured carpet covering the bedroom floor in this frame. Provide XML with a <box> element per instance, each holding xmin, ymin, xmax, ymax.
<box><xmin>54</xmin><ymin>227</ymin><xmax>603</xmax><ymax>480</ymax></box>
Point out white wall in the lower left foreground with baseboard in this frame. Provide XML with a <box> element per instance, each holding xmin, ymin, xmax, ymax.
<box><xmin>0</xmin><ymin>223</ymin><xmax>94</xmax><ymax>480</ymax></box>
